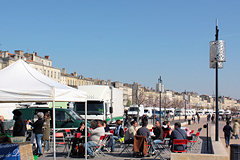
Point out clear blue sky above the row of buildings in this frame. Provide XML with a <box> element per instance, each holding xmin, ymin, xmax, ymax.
<box><xmin>0</xmin><ymin>0</ymin><xmax>240</xmax><ymax>99</ymax></box>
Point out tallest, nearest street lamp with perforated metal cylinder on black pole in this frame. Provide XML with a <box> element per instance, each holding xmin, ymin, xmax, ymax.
<box><xmin>210</xmin><ymin>21</ymin><xmax>226</xmax><ymax>141</ymax></box>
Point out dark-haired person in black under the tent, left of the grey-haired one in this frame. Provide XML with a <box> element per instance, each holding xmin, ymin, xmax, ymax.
<box><xmin>12</xmin><ymin>110</ymin><xmax>27</xmax><ymax>137</ymax></box>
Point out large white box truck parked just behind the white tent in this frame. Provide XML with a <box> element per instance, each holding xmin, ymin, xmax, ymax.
<box><xmin>73</xmin><ymin>85</ymin><xmax>124</xmax><ymax>122</ymax></box>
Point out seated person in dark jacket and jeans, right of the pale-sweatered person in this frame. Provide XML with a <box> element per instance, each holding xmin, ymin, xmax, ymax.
<box><xmin>108</xmin><ymin>120</ymin><xmax>124</xmax><ymax>152</ymax></box>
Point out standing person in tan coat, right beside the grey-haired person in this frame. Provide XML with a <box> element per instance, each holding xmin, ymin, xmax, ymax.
<box><xmin>43</xmin><ymin>112</ymin><xmax>51</xmax><ymax>152</ymax></box>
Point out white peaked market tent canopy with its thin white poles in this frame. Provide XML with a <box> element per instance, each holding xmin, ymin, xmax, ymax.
<box><xmin>0</xmin><ymin>59</ymin><xmax>87</xmax><ymax>159</ymax></box>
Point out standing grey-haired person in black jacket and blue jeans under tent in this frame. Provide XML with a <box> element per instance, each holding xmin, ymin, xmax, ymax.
<box><xmin>29</xmin><ymin>112</ymin><xmax>44</xmax><ymax>157</ymax></box>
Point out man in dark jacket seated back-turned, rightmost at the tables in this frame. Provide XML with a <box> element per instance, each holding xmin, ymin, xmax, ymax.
<box><xmin>170</xmin><ymin>122</ymin><xmax>187</xmax><ymax>151</ymax></box>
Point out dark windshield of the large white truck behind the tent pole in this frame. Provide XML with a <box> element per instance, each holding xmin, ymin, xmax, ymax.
<box><xmin>74</xmin><ymin>101</ymin><xmax>104</xmax><ymax>115</ymax></box>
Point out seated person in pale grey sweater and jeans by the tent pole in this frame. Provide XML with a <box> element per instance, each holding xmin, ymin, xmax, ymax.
<box><xmin>83</xmin><ymin>120</ymin><xmax>105</xmax><ymax>157</ymax></box>
